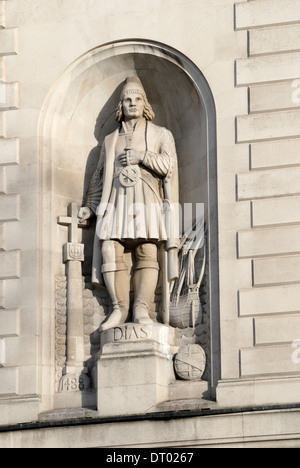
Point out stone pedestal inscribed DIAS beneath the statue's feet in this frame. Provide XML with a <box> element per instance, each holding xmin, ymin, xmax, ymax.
<box><xmin>97</xmin><ymin>324</ymin><xmax>177</xmax><ymax>417</ymax></box>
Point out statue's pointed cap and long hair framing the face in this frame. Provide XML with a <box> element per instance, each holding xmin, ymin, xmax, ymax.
<box><xmin>116</xmin><ymin>76</ymin><xmax>155</xmax><ymax>123</ymax></box>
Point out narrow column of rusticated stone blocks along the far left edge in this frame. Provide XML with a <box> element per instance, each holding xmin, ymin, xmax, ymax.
<box><xmin>0</xmin><ymin>0</ymin><xmax>22</xmax><ymax>406</ymax></box>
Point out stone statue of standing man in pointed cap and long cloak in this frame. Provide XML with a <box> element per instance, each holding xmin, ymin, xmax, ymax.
<box><xmin>78</xmin><ymin>76</ymin><xmax>178</xmax><ymax>330</ymax></box>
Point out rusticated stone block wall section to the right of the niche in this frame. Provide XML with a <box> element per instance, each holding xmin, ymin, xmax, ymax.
<box><xmin>219</xmin><ymin>0</ymin><xmax>300</xmax><ymax>405</ymax></box>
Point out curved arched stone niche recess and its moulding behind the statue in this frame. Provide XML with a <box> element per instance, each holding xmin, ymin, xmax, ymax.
<box><xmin>40</xmin><ymin>41</ymin><xmax>220</xmax><ymax>394</ymax></box>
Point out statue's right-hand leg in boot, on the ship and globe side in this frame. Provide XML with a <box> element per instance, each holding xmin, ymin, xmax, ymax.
<box><xmin>133</xmin><ymin>243</ymin><xmax>159</xmax><ymax>324</ymax></box>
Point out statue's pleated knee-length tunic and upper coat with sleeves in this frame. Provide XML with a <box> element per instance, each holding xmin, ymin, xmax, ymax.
<box><xmin>86</xmin><ymin>119</ymin><xmax>178</xmax><ymax>242</ymax></box>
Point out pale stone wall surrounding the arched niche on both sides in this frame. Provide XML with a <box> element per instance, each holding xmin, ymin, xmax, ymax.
<box><xmin>0</xmin><ymin>0</ymin><xmax>300</xmax><ymax>442</ymax></box>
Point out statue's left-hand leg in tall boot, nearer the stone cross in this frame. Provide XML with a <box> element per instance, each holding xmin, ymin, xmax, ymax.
<box><xmin>101</xmin><ymin>241</ymin><xmax>130</xmax><ymax>331</ymax></box>
